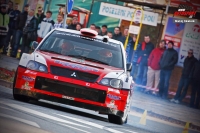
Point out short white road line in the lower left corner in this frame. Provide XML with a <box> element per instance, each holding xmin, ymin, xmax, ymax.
<box><xmin>0</xmin><ymin>113</ymin><xmax>40</xmax><ymax>128</ymax></box>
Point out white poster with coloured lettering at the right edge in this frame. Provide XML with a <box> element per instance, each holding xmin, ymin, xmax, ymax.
<box><xmin>178</xmin><ymin>22</ymin><xmax>200</xmax><ymax>66</ymax></box>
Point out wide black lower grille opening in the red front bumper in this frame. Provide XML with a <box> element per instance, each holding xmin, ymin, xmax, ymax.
<box><xmin>34</xmin><ymin>77</ymin><xmax>106</xmax><ymax>103</ymax></box>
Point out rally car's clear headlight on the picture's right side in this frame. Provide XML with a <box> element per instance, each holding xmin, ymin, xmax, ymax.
<box><xmin>100</xmin><ymin>78</ymin><xmax>123</xmax><ymax>88</ymax></box>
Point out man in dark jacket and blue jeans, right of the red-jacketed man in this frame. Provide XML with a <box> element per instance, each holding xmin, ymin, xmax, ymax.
<box><xmin>159</xmin><ymin>41</ymin><xmax>178</xmax><ymax>99</ymax></box>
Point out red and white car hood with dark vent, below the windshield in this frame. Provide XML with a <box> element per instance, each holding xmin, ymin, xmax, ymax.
<box><xmin>35</xmin><ymin>51</ymin><xmax>124</xmax><ymax>78</ymax></box>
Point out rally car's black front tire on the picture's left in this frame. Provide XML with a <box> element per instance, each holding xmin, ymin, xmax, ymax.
<box><xmin>13</xmin><ymin>68</ymin><xmax>30</xmax><ymax>102</ymax></box>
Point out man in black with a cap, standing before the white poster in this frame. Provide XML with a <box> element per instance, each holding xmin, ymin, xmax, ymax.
<box><xmin>170</xmin><ymin>49</ymin><xmax>198</xmax><ymax>103</ymax></box>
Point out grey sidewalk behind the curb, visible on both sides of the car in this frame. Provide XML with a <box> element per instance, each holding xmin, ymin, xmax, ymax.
<box><xmin>0</xmin><ymin>55</ymin><xmax>200</xmax><ymax>131</ymax></box>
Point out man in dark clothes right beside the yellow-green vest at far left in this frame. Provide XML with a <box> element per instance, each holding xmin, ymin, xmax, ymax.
<box><xmin>3</xmin><ymin>4</ymin><xmax>21</xmax><ymax>54</ymax></box>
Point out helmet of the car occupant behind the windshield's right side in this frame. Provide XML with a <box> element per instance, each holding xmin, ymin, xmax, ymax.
<box><xmin>98</xmin><ymin>49</ymin><xmax>113</xmax><ymax>63</ymax></box>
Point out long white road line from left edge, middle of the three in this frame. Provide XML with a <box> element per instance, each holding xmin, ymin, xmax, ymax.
<box><xmin>0</xmin><ymin>101</ymin><xmax>90</xmax><ymax>128</ymax></box>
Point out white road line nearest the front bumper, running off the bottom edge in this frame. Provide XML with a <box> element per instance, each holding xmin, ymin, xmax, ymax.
<box><xmin>54</xmin><ymin>113</ymin><xmax>123</xmax><ymax>133</ymax></box>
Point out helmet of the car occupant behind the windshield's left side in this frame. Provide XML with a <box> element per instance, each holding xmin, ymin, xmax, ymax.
<box><xmin>61</xmin><ymin>40</ymin><xmax>74</xmax><ymax>55</ymax></box>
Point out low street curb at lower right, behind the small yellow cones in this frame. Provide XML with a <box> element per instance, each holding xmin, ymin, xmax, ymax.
<box><xmin>131</xmin><ymin>106</ymin><xmax>200</xmax><ymax>131</ymax></box>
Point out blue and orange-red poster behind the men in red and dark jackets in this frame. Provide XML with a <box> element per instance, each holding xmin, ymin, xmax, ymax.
<box><xmin>164</xmin><ymin>16</ymin><xmax>185</xmax><ymax>57</ymax></box>
